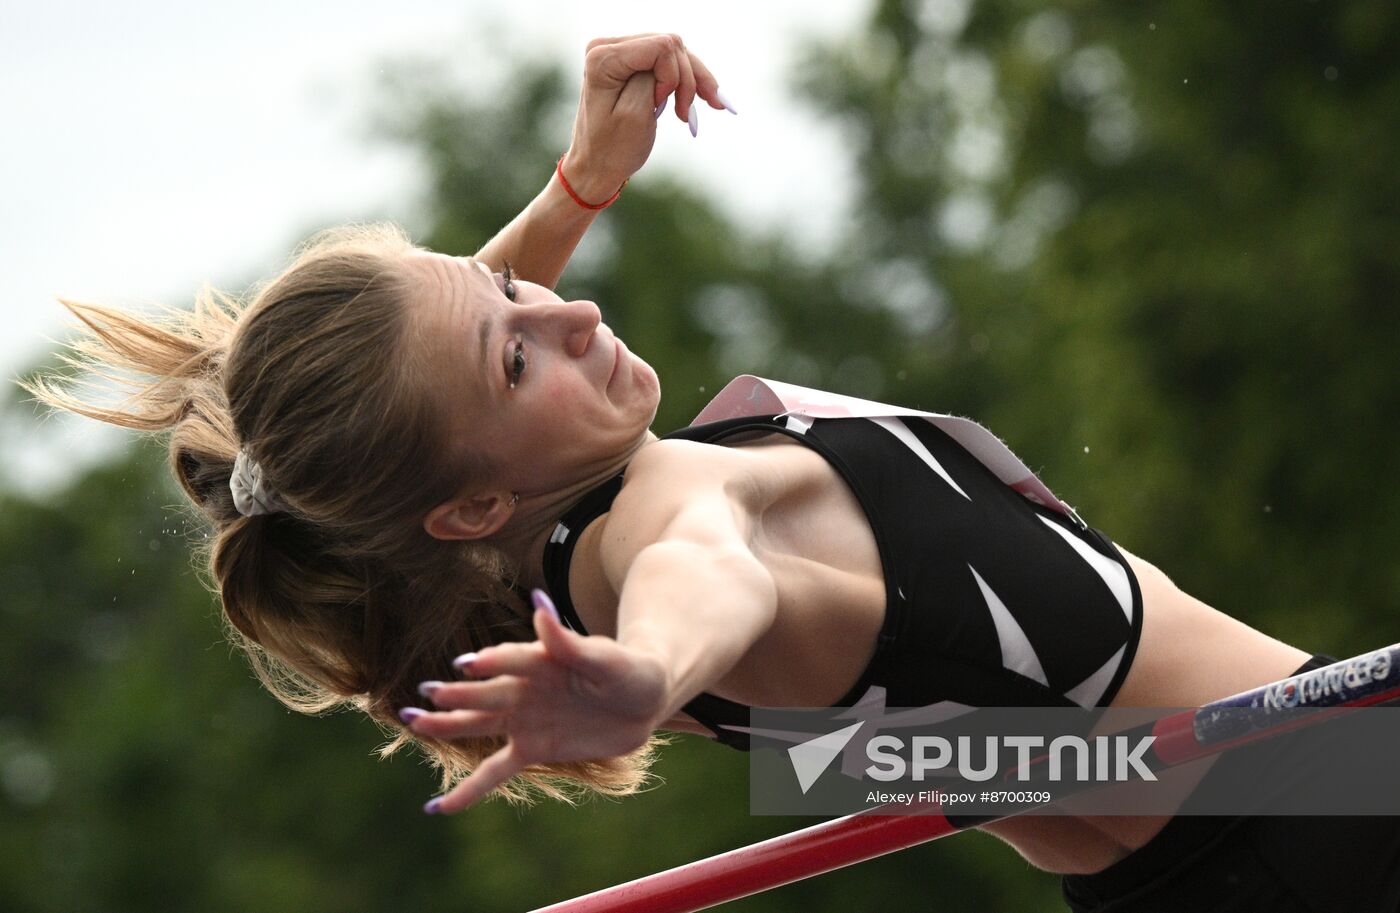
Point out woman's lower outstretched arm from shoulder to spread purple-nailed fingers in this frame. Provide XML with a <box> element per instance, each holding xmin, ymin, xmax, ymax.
<box><xmin>409</xmin><ymin>444</ymin><xmax>777</xmax><ymax>812</ymax></box>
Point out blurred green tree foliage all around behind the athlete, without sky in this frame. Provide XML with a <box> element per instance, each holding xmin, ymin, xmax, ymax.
<box><xmin>0</xmin><ymin>0</ymin><xmax>1400</xmax><ymax>913</ymax></box>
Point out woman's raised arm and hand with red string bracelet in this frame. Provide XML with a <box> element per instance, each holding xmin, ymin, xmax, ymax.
<box><xmin>476</xmin><ymin>35</ymin><xmax>725</xmax><ymax>288</ymax></box>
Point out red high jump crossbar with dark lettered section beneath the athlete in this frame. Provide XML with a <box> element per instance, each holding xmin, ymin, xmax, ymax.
<box><xmin>535</xmin><ymin>644</ymin><xmax>1400</xmax><ymax>913</ymax></box>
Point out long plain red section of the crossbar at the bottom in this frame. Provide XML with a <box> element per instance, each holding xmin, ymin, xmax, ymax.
<box><xmin>536</xmin><ymin>812</ymin><xmax>958</xmax><ymax>913</ymax></box>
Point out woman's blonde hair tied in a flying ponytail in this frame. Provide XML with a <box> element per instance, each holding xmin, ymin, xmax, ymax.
<box><xmin>22</xmin><ymin>224</ymin><xmax>657</xmax><ymax>801</ymax></box>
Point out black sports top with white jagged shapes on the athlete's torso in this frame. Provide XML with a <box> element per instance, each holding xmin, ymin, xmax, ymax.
<box><xmin>545</xmin><ymin>416</ymin><xmax>1142</xmax><ymax>749</ymax></box>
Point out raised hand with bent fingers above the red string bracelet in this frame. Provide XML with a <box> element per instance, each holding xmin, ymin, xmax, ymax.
<box><xmin>563</xmin><ymin>34</ymin><xmax>736</xmax><ymax>202</ymax></box>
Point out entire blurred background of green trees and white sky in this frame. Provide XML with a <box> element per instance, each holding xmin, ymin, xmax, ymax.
<box><xmin>0</xmin><ymin>0</ymin><xmax>1400</xmax><ymax>913</ymax></box>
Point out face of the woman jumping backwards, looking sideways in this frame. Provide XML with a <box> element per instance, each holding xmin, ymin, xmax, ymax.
<box><xmin>409</xmin><ymin>251</ymin><xmax>661</xmax><ymax>493</ymax></box>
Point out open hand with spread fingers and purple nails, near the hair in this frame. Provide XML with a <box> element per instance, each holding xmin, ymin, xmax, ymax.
<box><xmin>399</xmin><ymin>590</ymin><xmax>668</xmax><ymax>814</ymax></box>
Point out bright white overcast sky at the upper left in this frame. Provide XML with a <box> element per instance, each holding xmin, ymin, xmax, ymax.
<box><xmin>0</xmin><ymin>0</ymin><xmax>868</xmax><ymax>489</ymax></box>
